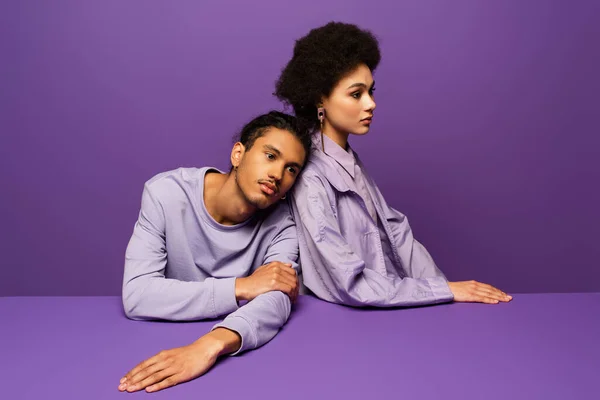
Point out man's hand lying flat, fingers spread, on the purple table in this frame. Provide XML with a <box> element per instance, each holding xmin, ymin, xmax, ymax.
<box><xmin>119</xmin><ymin>328</ymin><xmax>242</xmax><ymax>392</ymax></box>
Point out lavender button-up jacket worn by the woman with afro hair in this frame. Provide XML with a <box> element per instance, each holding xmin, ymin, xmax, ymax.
<box><xmin>290</xmin><ymin>134</ymin><xmax>453</xmax><ymax>307</ymax></box>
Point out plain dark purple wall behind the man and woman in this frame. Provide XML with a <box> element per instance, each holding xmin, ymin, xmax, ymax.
<box><xmin>0</xmin><ymin>0</ymin><xmax>600</xmax><ymax>296</ymax></box>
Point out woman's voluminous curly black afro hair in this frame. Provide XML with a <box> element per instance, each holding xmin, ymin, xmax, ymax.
<box><xmin>274</xmin><ymin>22</ymin><xmax>381</xmax><ymax>130</ymax></box>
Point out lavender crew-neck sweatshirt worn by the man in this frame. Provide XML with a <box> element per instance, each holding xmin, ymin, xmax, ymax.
<box><xmin>123</xmin><ymin>167</ymin><xmax>298</xmax><ymax>354</ymax></box>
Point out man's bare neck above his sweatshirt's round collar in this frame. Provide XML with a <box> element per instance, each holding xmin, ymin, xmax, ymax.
<box><xmin>203</xmin><ymin>172</ymin><xmax>256</xmax><ymax>225</ymax></box>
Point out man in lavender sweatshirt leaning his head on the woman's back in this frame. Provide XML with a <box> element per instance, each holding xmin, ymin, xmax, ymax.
<box><xmin>119</xmin><ymin>111</ymin><xmax>310</xmax><ymax>392</ymax></box>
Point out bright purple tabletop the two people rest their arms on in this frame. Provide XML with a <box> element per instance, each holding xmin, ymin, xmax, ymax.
<box><xmin>0</xmin><ymin>293</ymin><xmax>600</xmax><ymax>400</ymax></box>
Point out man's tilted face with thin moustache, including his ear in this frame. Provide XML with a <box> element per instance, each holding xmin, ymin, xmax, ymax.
<box><xmin>232</xmin><ymin>128</ymin><xmax>306</xmax><ymax>209</ymax></box>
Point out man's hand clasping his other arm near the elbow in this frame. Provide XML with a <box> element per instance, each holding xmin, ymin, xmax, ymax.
<box><xmin>235</xmin><ymin>261</ymin><xmax>299</xmax><ymax>302</ymax></box>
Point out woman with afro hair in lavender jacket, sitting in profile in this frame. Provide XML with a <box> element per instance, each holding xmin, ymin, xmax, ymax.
<box><xmin>275</xmin><ymin>22</ymin><xmax>512</xmax><ymax>307</ymax></box>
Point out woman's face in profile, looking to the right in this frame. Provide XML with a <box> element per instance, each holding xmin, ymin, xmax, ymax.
<box><xmin>323</xmin><ymin>64</ymin><xmax>375</xmax><ymax>135</ymax></box>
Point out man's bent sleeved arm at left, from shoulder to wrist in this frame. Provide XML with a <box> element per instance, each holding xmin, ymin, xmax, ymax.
<box><xmin>123</xmin><ymin>184</ymin><xmax>238</xmax><ymax>321</ymax></box>
